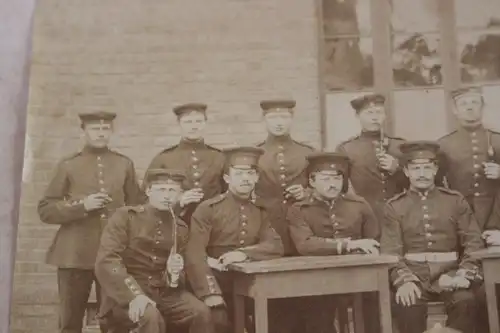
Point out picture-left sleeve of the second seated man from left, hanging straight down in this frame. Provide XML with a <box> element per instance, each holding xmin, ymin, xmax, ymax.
<box><xmin>186</xmin><ymin>204</ymin><xmax>222</xmax><ymax>299</ymax></box>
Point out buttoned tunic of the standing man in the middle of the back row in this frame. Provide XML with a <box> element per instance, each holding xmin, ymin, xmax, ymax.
<box><xmin>255</xmin><ymin>136</ymin><xmax>314</xmax><ymax>254</ymax></box>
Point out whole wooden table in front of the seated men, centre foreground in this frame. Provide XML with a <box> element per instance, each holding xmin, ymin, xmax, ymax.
<box><xmin>229</xmin><ymin>255</ymin><xmax>398</xmax><ymax>333</ymax></box>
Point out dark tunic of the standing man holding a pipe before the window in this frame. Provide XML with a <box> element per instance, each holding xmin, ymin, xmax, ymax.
<box><xmin>337</xmin><ymin>132</ymin><xmax>408</xmax><ymax>220</ymax></box>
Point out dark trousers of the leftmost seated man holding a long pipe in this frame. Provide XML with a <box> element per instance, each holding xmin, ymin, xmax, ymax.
<box><xmin>103</xmin><ymin>290</ymin><xmax>228</xmax><ymax>333</ymax></box>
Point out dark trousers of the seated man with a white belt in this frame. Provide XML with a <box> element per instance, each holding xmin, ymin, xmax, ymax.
<box><xmin>393</xmin><ymin>286</ymin><xmax>480</xmax><ymax>333</ymax></box>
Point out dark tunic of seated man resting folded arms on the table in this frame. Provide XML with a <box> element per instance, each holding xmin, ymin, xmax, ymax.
<box><xmin>288</xmin><ymin>193</ymin><xmax>380</xmax><ymax>255</ymax></box>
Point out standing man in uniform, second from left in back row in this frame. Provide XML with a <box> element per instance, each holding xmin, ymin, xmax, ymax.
<box><xmin>148</xmin><ymin>103</ymin><xmax>225</xmax><ymax>224</ymax></box>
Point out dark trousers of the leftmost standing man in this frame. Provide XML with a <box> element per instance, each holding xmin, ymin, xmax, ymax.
<box><xmin>57</xmin><ymin>268</ymin><xmax>100</xmax><ymax>333</ymax></box>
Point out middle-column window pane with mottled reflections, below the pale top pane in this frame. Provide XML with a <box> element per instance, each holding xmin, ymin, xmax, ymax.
<box><xmin>392</xmin><ymin>34</ymin><xmax>443</xmax><ymax>86</ymax></box>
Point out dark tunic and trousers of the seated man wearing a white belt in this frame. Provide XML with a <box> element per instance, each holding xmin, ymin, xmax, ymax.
<box><xmin>381</xmin><ymin>187</ymin><xmax>483</xmax><ymax>333</ymax></box>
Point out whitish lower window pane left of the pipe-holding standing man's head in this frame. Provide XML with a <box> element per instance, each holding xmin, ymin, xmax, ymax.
<box><xmin>326</xmin><ymin>92</ymin><xmax>369</xmax><ymax>150</ymax></box>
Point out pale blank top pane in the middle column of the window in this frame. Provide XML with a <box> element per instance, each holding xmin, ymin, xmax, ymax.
<box><xmin>390</xmin><ymin>0</ymin><xmax>439</xmax><ymax>33</ymax></box>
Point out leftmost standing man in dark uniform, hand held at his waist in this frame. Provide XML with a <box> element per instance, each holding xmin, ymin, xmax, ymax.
<box><xmin>38</xmin><ymin>112</ymin><xmax>142</xmax><ymax>333</ymax></box>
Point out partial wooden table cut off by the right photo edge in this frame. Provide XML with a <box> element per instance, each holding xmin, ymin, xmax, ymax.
<box><xmin>471</xmin><ymin>246</ymin><xmax>500</xmax><ymax>333</ymax></box>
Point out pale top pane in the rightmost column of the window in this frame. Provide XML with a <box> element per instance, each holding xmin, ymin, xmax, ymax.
<box><xmin>455</xmin><ymin>0</ymin><xmax>500</xmax><ymax>28</ymax></box>
